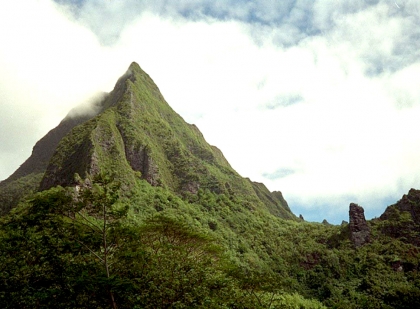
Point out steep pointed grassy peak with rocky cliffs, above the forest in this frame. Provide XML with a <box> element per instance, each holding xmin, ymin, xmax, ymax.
<box><xmin>41</xmin><ymin>63</ymin><xmax>294</xmax><ymax>219</ymax></box>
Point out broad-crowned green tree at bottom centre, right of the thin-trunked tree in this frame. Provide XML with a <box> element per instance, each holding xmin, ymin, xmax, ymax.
<box><xmin>132</xmin><ymin>215</ymin><xmax>229</xmax><ymax>308</ymax></box>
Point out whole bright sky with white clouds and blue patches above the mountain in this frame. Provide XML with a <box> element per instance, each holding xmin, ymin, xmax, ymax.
<box><xmin>0</xmin><ymin>0</ymin><xmax>420</xmax><ymax>224</ymax></box>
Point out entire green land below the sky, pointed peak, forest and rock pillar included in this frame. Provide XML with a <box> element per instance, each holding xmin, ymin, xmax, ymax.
<box><xmin>0</xmin><ymin>63</ymin><xmax>420</xmax><ymax>308</ymax></box>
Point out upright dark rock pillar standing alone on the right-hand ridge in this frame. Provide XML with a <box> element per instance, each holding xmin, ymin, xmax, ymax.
<box><xmin>349</xmin><ymin>203</ymin><xmax>370</xmax><ymax>248</ymax></box>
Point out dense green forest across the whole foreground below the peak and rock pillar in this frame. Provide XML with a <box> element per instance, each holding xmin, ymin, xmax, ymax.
<box><xmin>0</xmin><ymin>176</ymin><xmax>420</xmax><ymax>308</ymax></box>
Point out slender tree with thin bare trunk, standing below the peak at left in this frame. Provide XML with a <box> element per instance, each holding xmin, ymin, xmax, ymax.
<box><xmin>61</xmin><ymin>174</ymin><xmax>128</xmax><ymax>309</ymax></box>
